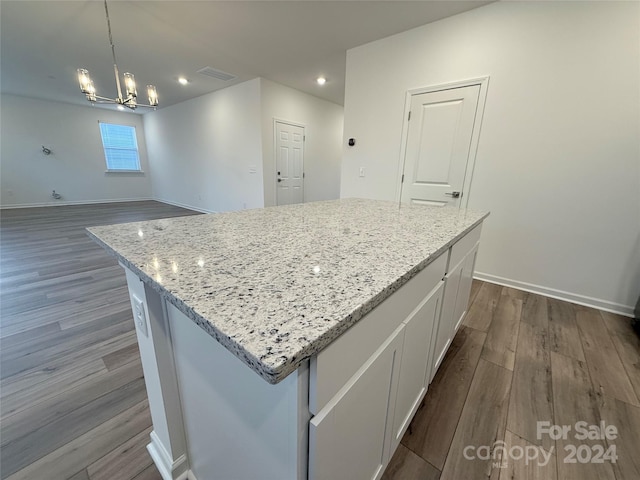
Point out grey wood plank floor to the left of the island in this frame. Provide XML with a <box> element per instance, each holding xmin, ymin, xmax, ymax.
<box><xmin>0</xmin><ymin>202</ymin><xmax>196</xmax><ymax>480</ymax></box>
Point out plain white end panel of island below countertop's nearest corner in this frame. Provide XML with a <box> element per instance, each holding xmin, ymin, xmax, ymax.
<box><xmin>167</xmin><ymin>304</ymin><xmax>309</xmax><ymax>480</ymax></box>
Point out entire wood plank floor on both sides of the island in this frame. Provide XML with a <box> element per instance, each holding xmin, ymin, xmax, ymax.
<box><xmin>0</xmin><ymin>202</ymin><xmax>640</xmax><ymax>480</ymax></box>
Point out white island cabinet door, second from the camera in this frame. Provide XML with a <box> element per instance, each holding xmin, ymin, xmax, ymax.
<box><xmin>391</xmin><ymin>281</ymin><xmax>444</xmax><ymax>453</ymax></box>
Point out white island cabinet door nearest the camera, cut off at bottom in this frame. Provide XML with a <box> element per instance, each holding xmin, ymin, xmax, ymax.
<box><xmin>309</xmin><ymin>325</ymin><xmax>404</xmax><ymax>480</ymax></box>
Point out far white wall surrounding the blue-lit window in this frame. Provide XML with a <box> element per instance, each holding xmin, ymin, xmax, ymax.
<box><xmin>0</xmin><ymin>94</ymin><xmax>151</xmax><ymax>207</ymax></box>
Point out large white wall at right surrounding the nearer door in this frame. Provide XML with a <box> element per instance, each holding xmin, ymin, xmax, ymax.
<box><xmin>341</xmin><ymin>2</ymin><xmax>640</xmax><ymax>313</ymax></box>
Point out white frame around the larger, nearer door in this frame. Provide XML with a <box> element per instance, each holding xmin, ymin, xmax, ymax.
<box><xmin>396</xmin><ymin>75</ymin><xmax>489</xmax><ymax>208</ymax></box>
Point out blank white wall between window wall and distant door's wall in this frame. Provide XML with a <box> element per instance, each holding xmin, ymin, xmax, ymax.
<box><xmin>144</xmin><ymin>79</ymin><xmax>264</xmax><ymax>212</ymax></box>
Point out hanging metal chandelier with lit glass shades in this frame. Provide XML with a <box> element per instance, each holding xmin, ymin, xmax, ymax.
<box><xmin>78</xmin><ymin>0</ymin><xmax>158</xmax><ymax>110</ymax></box>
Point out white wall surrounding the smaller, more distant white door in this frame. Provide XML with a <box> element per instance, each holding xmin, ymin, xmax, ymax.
<box><xmin>260</xmin><ymin>78</ymin><xmax>344</xmax><ymax>206</ymax></box>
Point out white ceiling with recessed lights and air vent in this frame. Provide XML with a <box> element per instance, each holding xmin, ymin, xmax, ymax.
<box><xmin>0</xmin><ymin>0</ymin><xmax>490</xmax><ymax>113</ymax></box>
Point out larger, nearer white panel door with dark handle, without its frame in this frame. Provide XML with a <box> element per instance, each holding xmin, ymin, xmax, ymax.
<box><xmin>401</xmin><ymin>84</ymin><xmax>481</xmax><ymax>206</ymax></box>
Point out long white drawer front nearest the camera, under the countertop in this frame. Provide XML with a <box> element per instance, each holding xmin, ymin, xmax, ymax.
<box><xmin>309</xmin><ymin>255</ymin><xmax>447</xmax><ymax>415</ymax></box>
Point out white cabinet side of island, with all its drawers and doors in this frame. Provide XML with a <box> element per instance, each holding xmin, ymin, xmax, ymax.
<box><xmin>308</xmin><ymin>225</ymin><xmax>481</xmax><ymax>480</ymax></box>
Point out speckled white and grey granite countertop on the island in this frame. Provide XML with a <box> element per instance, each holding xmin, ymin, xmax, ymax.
<box><xmin>87</xmin><ymin>199</ymin><xmax>488</xmax><ymax>383</ymax></box>
